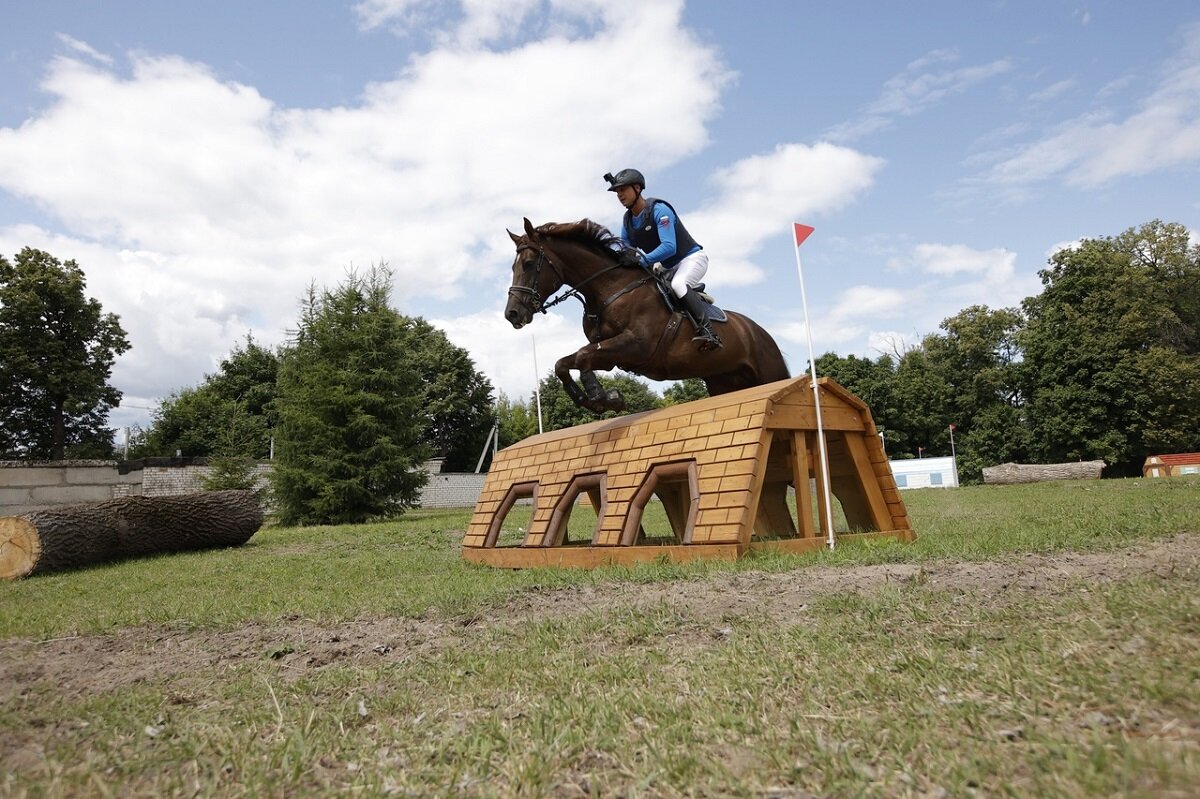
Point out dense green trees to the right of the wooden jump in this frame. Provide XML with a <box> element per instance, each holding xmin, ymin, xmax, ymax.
<box><xmin>817</xmin><ymin>221</ymin><xmax>1200</xmax><ymax>480</ymax></box>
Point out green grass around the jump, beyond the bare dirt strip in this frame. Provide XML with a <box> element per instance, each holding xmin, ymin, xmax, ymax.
<box><xmin>0</xmin><ymin>479</ymin><xmax>1200</xmax><ymax>638</ymax></box>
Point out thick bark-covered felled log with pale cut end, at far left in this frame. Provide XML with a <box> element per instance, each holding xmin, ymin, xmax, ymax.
<box><xmin>0</xmin><ymin>491</ymin><xmax>263</xmax><ymax>579</ymax></box>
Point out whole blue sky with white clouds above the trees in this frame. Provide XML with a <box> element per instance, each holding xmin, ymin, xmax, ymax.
<box><xmin>0</xmin><ymin>0</ymin><xmax>1200</xmax><ymax>443</ymax></box>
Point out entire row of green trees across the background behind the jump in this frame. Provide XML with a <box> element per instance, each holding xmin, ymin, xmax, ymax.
<box><xmin>0</xmin><ymin>221</ymin><xmax>1200</xmax><ymax>515</ymax></box>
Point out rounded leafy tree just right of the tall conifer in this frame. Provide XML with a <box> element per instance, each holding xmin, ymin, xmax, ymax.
<box><xmin>403</xmin><ymin>317</ymin><xmax>496</xmax><ymax>471</ymax></box>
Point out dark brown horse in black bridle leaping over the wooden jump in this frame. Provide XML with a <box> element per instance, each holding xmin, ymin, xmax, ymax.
<box><xmin>504</xmin><ymin>218</ymin><xmax>791</xmax><ymax>414</ymax></box>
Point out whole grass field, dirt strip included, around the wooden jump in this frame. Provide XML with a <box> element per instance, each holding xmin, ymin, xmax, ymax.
<box><xmin>0</xmin><ymin>479</ymin><xmax>1200</xmax><ymax>797</ymax></box>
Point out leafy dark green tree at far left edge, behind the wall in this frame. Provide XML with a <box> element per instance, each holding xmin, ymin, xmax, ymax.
<box><xmin>0</xmin><ymin>247</ymin><xmax>130</xmax><ymax>459</ymax></box>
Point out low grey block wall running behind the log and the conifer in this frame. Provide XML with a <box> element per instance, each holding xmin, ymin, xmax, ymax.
<box><xmin>0</xmin><ymin>458</ymin><xmax>486</xmax><ymax>516</ymax></box>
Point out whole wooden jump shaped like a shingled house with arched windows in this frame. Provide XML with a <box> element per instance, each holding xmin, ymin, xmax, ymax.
<box><xmin>462</xmin><ymin>377</ymin><xmax>914</xmax><ymax>569</ymax></box>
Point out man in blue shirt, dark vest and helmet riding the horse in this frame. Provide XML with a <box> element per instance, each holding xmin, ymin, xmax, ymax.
<box><xmin>604</xmin><ymin>169</ymin><xmax>721</xmax><ymax>349</ymax></box>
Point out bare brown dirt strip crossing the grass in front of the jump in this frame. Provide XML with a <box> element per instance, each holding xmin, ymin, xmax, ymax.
<box><xmin>0</xmin><ymin>534</ymin><xmax>1200</xmax><ymax>704</ymax></box>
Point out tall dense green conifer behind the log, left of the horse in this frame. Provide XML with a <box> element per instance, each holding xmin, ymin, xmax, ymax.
<box><xmin>271</xmin><ymin>266</ymin><xmax>427</xmax><ymax>524</ymax></box>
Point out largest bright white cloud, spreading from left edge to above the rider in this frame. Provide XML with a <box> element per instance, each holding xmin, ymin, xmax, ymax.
<box><xmin>0</xmin><ymin>1</ymin><xmax>730</xmax><ymax>410</ymax></box>
